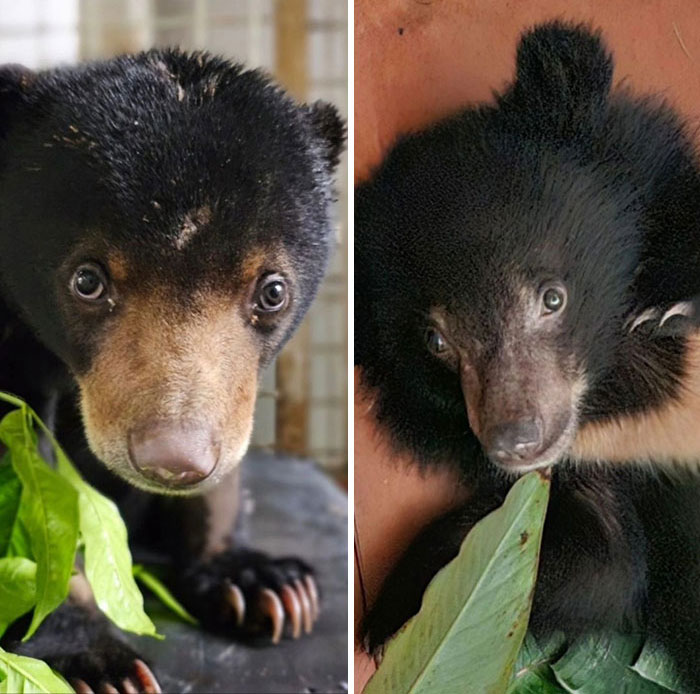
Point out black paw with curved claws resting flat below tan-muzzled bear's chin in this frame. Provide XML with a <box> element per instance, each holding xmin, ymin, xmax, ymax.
<box><xmin>178</xmin><ymin>550</ymin><xmax>320</xmax><ymax>644</ymax></box>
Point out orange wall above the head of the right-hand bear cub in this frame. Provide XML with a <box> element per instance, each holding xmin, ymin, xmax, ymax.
<box><xmin>355</xmin><ymin>0</ymin><xmax>700</xmax><ymax>180</ymax></box>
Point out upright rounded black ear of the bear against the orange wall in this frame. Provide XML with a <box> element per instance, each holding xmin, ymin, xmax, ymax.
<box><xmin>513</xmin><ymin>21</ymin><xmax>613</xmax><ymax>113</ymax></box>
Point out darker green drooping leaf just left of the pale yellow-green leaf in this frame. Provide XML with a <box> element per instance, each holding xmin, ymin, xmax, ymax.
<box><xmin>0</xmin><ymin>410</ymin><xmax>78</xmax><ymax>640</ymax></box>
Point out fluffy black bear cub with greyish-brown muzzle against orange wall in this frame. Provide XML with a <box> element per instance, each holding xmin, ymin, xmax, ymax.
<box><xmin>355</xmin><ymin>22</ymin><xmax>700</xmax><ymax>688</ymax></box>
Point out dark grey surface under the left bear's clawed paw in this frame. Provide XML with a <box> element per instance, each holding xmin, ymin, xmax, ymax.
<box><xmin>124</xmin><ymin>452</ymin><xmax>348</xmax><ymax>694</ymax></box>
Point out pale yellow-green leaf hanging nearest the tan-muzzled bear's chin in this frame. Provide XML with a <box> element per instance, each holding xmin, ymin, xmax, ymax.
<box><xmin>54</xmin><ymin>454</ymin><xmax>158</xmax><ymax>636</ymax></box>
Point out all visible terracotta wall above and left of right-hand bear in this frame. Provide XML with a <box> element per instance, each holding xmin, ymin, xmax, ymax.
<box><xmin>355</xmin><ymin>0</ymin><xmax>700</xmax><ymax>691</ymax></box>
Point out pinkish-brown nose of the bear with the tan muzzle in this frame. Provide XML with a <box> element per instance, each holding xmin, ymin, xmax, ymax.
<box><xmin>129</xmin><ymin>422</ymin><xmax>219</xmax><ymax>487</ymax></box>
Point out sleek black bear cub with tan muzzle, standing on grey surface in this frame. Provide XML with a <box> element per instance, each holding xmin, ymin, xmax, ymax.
<box><xmin>0</xmin><ymin>50</ymin><xmax>344</xmax><ymax>691</ymax></box>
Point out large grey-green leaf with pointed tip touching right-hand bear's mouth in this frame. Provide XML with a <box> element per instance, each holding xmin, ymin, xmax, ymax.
<box><xmin>365</xmin><ymin>472</ymin><xmax>549</xmax><ymax>694</ymax></box>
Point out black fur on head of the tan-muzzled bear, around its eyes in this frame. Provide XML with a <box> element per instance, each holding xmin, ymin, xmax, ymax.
<box><xmin>0</xmin><ymin>50</ymin><xmax>344</xmax><ymax>372</ymax></box>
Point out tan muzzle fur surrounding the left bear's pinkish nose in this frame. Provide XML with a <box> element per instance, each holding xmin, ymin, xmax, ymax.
<box><xmin>76</xmin><ymin>290</ymin><xmax>261</xmax><ymax>493</ymax></box>
